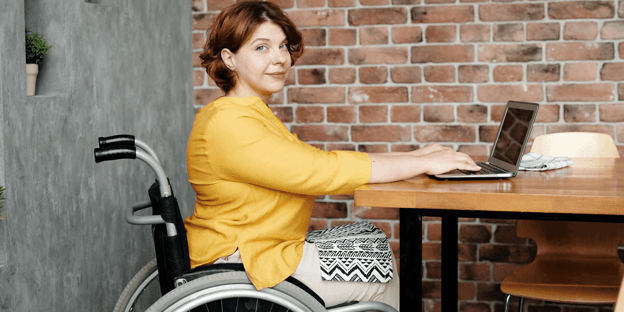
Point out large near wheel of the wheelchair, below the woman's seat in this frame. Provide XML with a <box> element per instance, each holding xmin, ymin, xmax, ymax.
<box><xmin>147</xmin><ymin>272</ymin><xmax>326</xmax><ymax>312</ymax></box>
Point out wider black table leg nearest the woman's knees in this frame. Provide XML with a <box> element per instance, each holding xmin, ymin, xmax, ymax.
<box><xmin>399</xmin><ymin>208</ymin><xmax>422</xmax><ymax>312</ymax></box>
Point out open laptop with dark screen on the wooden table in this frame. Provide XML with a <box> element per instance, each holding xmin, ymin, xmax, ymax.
<box><xmin>435</xmin><ymin>101</ymin><xmax>539</xmax><ymax>179</ymax></box>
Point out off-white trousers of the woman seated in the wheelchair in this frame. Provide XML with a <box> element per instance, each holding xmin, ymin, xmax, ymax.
<box><xmin>215</xmin><ymin>242</ymin><xmax>399</xmax><ymax>310</ymax></box>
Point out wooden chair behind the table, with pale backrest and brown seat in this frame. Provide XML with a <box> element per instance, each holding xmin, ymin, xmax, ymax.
<box><xmin>500</xmin><ymin>132</ymin><xmax>624</xmax><ymax>311</ymax></box>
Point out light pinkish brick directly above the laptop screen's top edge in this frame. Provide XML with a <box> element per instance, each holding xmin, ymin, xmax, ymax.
<box><xmin>477</xmin><ymin>84</ymin><xmax>544</xmax><ymax>103</ymax></box>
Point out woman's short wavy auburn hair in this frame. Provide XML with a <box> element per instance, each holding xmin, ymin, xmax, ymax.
<box><xmin>199</xmin><ymin>1</ymin><xmax>304</xmax><ymax>93</ymax></box>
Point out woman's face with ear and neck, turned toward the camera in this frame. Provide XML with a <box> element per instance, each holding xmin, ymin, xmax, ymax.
<box><xmin>221</xmin><ymin>22</ymin><xmax>292</xmax><ymax>103</ymax></box>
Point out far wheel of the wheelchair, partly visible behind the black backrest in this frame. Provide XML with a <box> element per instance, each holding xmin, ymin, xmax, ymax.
<box><xmin>113</xmin><ymin>259</ymin><xmax>161</xmax><ymax>312</ymax></box>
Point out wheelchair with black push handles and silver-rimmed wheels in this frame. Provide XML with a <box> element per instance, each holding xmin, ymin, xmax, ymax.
<box><xmin>94</xmin><ymin>134</ymin><xmax>397</xmax><ymax>312</ymax></box>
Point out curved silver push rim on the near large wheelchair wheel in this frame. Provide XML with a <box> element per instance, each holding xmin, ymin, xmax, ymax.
<box><xmin>164</xmin><ymin>285</ymin><xmax>310</xmax><ymax>312</ymax></box>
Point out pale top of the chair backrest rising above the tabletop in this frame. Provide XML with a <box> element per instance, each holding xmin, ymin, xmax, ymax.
<box><xmin>531</xmin><ymin>132</ymin><xmax>620</xmax><ymax>158</ymax></box>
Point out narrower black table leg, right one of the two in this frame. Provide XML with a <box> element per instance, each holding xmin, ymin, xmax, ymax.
<box><xmin>441</xmin><ymin>215</ymin><xmax>459</xmax><ymax>311</ymax></box>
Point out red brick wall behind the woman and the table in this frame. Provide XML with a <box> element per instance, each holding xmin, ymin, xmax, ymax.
<box><xmin>192</xmin><ymin>0</ymin><xmax>624</xmax><ymax>312</ymax></box>
